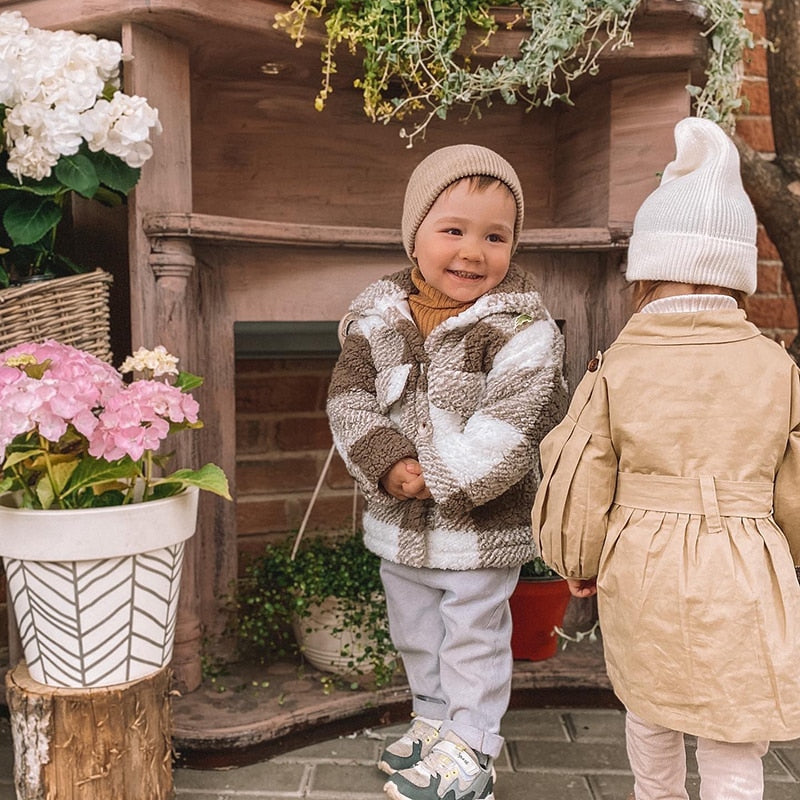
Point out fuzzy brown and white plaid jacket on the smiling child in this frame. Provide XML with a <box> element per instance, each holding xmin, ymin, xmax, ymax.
<box><xmin>327</xmin><ymin>266</ymin><xmax>567</xmax><ymax>570</ymax></box>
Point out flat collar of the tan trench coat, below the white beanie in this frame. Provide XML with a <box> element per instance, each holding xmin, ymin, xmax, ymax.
<box><xmin>617</xmin><ymin>308</ymin><xmax>761</xmax><ymax>345</ymax></box>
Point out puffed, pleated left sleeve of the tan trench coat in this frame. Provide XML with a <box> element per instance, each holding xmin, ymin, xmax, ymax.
<box><xmin>532</xmin><ymin>364</ymin><xmax>618</xmax><ymax>578</ymax></box>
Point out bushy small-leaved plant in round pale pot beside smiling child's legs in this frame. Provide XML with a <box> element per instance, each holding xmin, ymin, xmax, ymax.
<box><xmin>237</xmin><ymin>531</ymin><xmax>397</xmax><ymax>686</ymax></box>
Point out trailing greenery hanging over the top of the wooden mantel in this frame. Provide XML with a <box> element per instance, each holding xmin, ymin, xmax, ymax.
<box><xmin>275</xmin><ymin>0</ymin><xmax>753</xmax><ymax>147</ymax></box>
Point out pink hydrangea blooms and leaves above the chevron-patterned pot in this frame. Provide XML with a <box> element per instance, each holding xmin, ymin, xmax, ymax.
<box><xmin>0</xmin><ymin>341</ymin><xmax>230</xmax><ymax>509</ymax></box>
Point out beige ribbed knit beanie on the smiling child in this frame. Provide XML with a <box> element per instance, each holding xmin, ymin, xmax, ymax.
<box><xmin>402</xmin><ymin>144</ymin><xmax>525</xmax><ymax>258</ymax></box>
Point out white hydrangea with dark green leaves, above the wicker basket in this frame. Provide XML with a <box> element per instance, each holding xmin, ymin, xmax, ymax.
<box><xmin>0</xmin><ymin>11</ymin><xmax>161</xmax><ymax>286</ymax></box>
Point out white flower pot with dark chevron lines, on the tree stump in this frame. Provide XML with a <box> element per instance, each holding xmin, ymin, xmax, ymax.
<box><xmin>0</xmin><ymin>488</ymin><xmax>198</xmax><ymax>688</ymax></box>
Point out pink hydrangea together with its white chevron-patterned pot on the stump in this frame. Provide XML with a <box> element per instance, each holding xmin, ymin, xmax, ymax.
<box><xmin>0</xmin><ymin>341</ymin><xmax>230</xmax><ymax>688</ymax></box>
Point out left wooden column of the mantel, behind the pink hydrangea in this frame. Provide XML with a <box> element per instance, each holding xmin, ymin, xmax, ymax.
<box><xmin>122</xmin><ymin>23</ymin><xmax>206</xmax><ymax>692</ymax></box>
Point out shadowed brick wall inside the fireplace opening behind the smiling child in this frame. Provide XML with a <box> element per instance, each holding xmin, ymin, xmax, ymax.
<box><xmin>236</xmin><ymin>357</ymin><xmax>362</xmax><ymax>562</ymax></box>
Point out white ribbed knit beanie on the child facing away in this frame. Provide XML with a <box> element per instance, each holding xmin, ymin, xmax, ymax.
<box><xmin>625</xmin><ymin>117</ymin><xmax>757</xmax><ymax>294</ymax></box>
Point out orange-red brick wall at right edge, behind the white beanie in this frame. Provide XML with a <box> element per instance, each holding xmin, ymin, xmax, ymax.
<box><xmin>736</xmin><ymin>2</ymin><xmax>798</xmax><ymax>346</ymax></box>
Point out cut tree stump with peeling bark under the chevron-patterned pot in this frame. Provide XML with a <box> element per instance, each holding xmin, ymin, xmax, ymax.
<box><xmin>6</xmin><ymin>662</ymin><xmax>174</xmax><ymax>800</ymax></box>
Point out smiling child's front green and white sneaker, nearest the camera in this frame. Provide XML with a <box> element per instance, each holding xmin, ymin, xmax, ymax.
<box><xmin>383</xmin><ymin>731</ymin><xmax>494</xmax><ymax>800</ymax></box>
